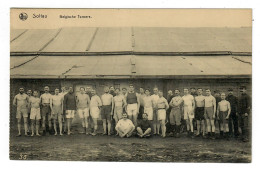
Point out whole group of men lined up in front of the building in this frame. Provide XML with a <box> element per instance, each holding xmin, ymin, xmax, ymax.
<box><xmin>13</xmin><ymin>84</ymin><xmax>251</xmax><ymax>142</ymax></box>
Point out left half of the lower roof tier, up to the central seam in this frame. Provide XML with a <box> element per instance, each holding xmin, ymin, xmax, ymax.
<box><xmin>11</xmin><ymin>56</ymin><xmax>131</xmax><ymax>78</ymax></box>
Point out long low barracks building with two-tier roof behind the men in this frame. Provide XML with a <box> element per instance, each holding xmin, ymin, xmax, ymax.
<box><xmin>10</xmin><ymin>27</ymin><xmax>252</xmax><ymax>125</ymax></box>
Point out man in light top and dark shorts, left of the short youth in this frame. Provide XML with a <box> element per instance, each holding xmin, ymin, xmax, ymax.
<box><xmin>204</xmin><ymin>89</ymin><xmax>216</xmax><ymax>139</ymax></box>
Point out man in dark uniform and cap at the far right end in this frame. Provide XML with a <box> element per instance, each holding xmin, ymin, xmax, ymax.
<box><xmin>238</xmin><ymin>86</ymin><xmax>251</xmax><ymax>142</ymax></box>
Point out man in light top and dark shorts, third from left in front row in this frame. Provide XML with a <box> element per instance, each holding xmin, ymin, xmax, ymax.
<box><xmin>40</xmin><ymin>86</ymin><xmax>52</xmax><ymax>135</ymax></box>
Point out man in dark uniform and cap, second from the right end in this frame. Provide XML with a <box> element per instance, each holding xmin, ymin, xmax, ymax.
<box><xmin>226</xmin><ymin>88</ymin><xmax>239</xmax><ymax>138</ymax></box>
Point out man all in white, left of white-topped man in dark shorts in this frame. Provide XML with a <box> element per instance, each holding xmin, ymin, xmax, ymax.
<box><xmin>90</xmin><ymin>90</ymin><xmax>102</xmax><ymax>136</ymax></box>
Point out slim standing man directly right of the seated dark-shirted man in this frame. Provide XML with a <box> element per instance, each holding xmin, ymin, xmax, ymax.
<box><xmin>151</xmin><ymin>87</ymin><xmax>160</xmax><ymax>135</ymax></box>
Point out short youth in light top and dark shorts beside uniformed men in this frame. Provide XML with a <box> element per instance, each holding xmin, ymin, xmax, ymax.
<box><xmin>217</xmin><ymin>93</ymin><xmax>231</xmax><ymax>140</ymax></box>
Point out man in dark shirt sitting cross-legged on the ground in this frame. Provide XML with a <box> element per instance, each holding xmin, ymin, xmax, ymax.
<box><xmin>136</xmin><ymin>113</ymin><xmax>152</xmax><ymax>138</ymax></box>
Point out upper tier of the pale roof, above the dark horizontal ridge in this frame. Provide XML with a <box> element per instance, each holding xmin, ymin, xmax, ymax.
<box><xmin>11</xmin><ymin>27</ymin><xmax>252</xmax><ymax>53</ymax></box>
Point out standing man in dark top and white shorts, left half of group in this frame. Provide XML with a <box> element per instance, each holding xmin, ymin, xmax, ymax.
<box><xmin>63</xmin><ymin>87</ymin><xmax>76</xmax><ymax>135</ymax></box>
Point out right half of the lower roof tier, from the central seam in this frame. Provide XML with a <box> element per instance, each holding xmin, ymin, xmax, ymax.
<box><xmin>136</xmin><ymin>56</ymin><xmax>252</xmax><ymax>76</ymax></box>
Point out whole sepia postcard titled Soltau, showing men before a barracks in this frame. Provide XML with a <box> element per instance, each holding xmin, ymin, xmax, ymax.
<box><xmin>9</xmin><ymin>8</ymin><xmax>252</xmax><ymax>163</ymax></box>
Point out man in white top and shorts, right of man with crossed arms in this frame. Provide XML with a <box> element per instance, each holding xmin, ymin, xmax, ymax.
<box><xmin>182</xmin><ymin>88</ymin><xmax>195</xmax><ymax>138</ymax></box>
